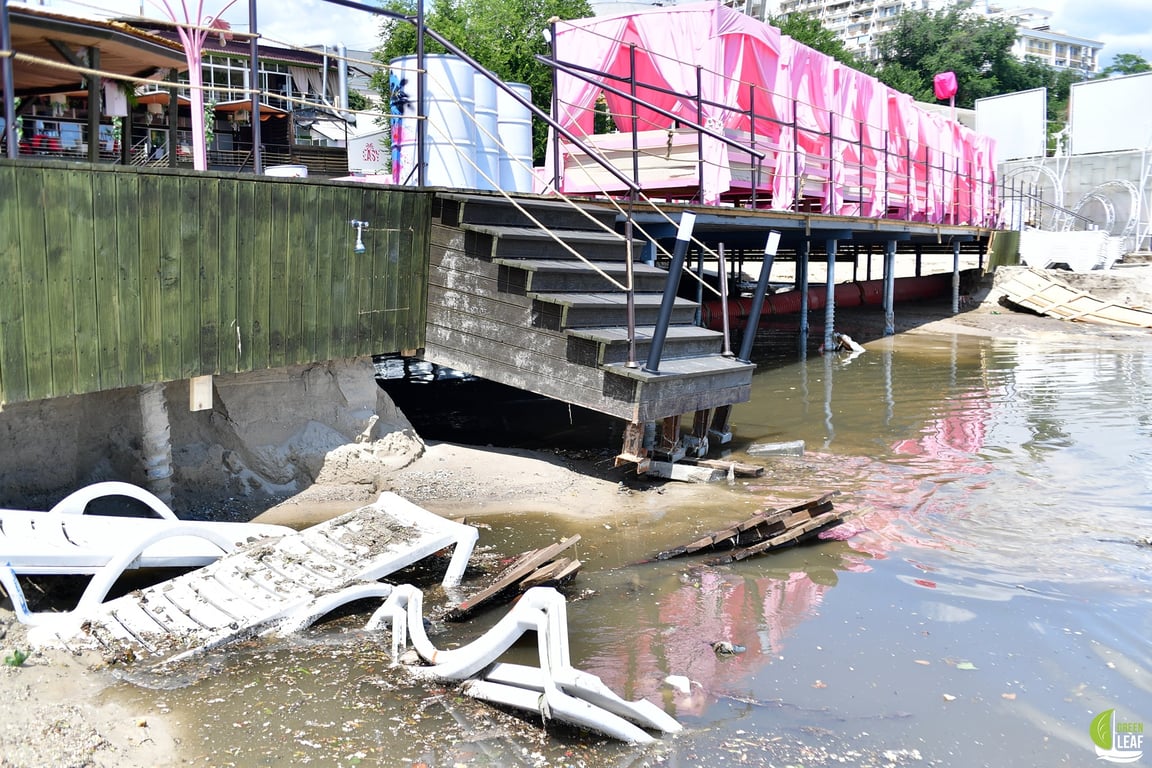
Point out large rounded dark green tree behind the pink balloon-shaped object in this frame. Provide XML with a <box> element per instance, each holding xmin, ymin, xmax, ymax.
<box><xmin>876</xmin><ymin>6</ymin><xmax>1046</xmax><ymax>108</ymax></box>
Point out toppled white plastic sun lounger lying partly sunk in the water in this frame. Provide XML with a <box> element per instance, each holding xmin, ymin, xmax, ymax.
<box><xmin>365</xmin><ymin>584</ymin><xmax>681</xmax><ymax>744</ymax></box>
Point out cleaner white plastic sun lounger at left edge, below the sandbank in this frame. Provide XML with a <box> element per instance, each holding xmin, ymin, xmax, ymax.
<box><xmin>0</xmin><ymin>482</ymin><xmax>294</xmax><ymax>624</ymax></box>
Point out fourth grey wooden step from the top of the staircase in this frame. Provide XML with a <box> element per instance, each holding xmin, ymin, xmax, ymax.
<box><xmin>529</xmin><ymin>292</ymin><xmax>697</xmax><ymax>330</ymax></box>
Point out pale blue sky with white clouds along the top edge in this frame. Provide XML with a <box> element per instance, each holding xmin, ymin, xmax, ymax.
<box><xmin>15</xmin><ymin>0</ymin><xmax>1152</xmax><ymax>64</ymax></box>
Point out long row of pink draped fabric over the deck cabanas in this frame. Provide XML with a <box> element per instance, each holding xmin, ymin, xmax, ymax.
<box><xmin>548</xmin><ymin>3</ymin><xmax>995</xmax><ymax>225</ymax></box>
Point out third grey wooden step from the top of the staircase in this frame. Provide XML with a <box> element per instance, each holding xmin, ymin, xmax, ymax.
<box><xmin>493</xmin><ymin>258</ymin><xmax>668</xmax><ymax>296</ymax></box>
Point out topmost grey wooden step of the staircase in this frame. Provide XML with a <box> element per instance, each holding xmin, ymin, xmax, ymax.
<box><xmin>438</xmin><ymin>192</ymin><xmax>616</xmax><ymax>231</ymax></box>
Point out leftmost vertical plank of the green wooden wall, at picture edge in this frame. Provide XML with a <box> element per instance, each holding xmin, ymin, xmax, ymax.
<box><xmin>0</xmin><ymin>166</ymin><xmax>29</xmax><ymax>404</ymax></box>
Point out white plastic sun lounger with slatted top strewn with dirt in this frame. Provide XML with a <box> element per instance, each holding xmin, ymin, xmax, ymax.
<box><xmin>29</xmin><ymin>493</ymin><xmax>478</xmax><ymax>661</ymax></box>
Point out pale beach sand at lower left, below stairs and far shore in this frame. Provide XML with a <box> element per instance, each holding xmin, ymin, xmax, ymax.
<box><xmin>0</xmin><ymin>270</ymin><xmax>1152</xmax><ymax>768</ymax></box>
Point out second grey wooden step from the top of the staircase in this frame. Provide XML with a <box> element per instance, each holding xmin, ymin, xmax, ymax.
<box><xmin>460</xmin><ymin>225</ymin><xmax>644</xmax><ymax>261</ymax></box>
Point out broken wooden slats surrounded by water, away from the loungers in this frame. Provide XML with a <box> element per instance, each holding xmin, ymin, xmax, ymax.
<box><xmin>644</xmin><ymin>491</ymin><xmax>846</xmax><ymax>565</ymax></box>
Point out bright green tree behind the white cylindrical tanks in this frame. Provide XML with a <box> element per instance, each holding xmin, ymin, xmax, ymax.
<box><xmin>372</xmin><ymin>0</ymin><xmax>592</xmax><ymax>161</ymax></box>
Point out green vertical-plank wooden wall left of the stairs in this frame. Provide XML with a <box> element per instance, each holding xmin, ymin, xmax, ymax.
<box><xmin>0</xmin><ymin>159</ymin><xmax>432</xmax><ymax>404</ymax></box>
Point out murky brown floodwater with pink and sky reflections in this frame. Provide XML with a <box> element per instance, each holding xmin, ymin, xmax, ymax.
<box><xmin>116</xmin><ymin>335</ymin><xmax>1152</xmax><ymax>768</ymax></box>
